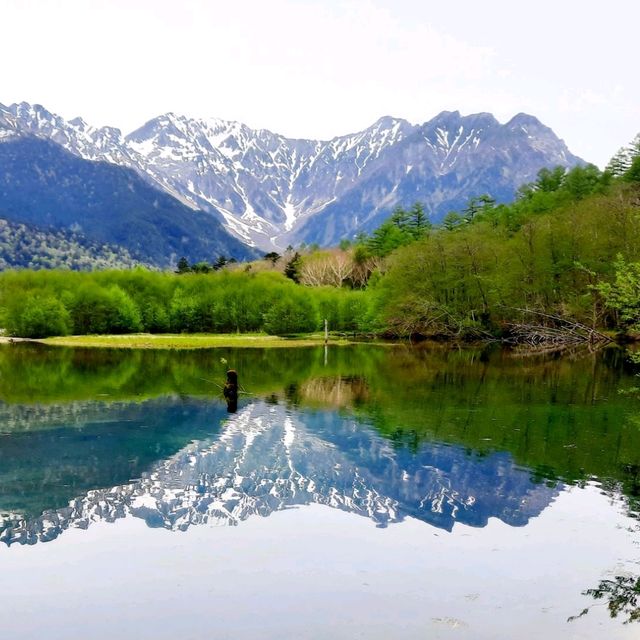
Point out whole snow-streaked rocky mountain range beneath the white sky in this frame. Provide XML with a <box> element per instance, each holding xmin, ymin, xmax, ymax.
<box><xmin>0</xmin><ymin>103</ymin><xmax>581</xmax><ymax>249</ymax></box>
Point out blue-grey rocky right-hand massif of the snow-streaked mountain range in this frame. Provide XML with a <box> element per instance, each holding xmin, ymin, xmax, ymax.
<box><xmin>297</xmin><ymin>111</ymin><xmax>582</xmax><ymax>244</ymax></box>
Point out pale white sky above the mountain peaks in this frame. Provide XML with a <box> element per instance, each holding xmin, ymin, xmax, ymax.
<box><xmin>0</xmin><ymin>0</ymin><xmax>640</xmax><ymax>166</ymax></box>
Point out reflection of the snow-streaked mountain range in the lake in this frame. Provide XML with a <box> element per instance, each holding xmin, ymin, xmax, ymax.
<box><xmin>0</xmin><ymin>403</ymin><xmax>558</xmax><ymax>544</ymax></box>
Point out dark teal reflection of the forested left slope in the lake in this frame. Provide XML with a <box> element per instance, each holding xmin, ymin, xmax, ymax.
<box><xmin>0</xmin><ymin>396</ymin><xmax>232</xmax><ymax>529</ymax></box>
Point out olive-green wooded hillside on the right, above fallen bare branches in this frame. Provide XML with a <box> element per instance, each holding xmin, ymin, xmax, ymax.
<box><xmin>375</xmin><ymin>178</ymin><xmax>640</xmax><ymax>337</ymax></box>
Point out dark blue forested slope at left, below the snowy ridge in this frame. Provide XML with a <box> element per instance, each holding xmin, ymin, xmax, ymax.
<box><xmin>0</xmin><ymin>134</ymin><xmax>251</xmax><ymax>266</ymax></box>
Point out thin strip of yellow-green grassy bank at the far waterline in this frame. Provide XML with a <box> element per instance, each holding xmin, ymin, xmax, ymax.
<box><xmin>37</xmin><ymin>333</ymin><xmax>364</xmax><ymax>349</ymax></box>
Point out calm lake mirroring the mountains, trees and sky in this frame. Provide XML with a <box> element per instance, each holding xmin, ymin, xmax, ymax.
<box><xmin>0</xmin><ymin>344</ymin><xmax>640</xmax><ymax>640</ymax></box>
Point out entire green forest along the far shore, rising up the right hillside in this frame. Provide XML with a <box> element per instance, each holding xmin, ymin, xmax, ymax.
<box><xmin>0</xmin><ymin>139</ymin><xmax>640</xmax><ymax>338</ymax></box>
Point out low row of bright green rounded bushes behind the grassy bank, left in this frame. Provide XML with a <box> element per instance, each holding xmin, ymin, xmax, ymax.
<box><xmin>0</xmin><ymin>268</ymin><xmax>370</xmax><ymax>338</ymax></box>
